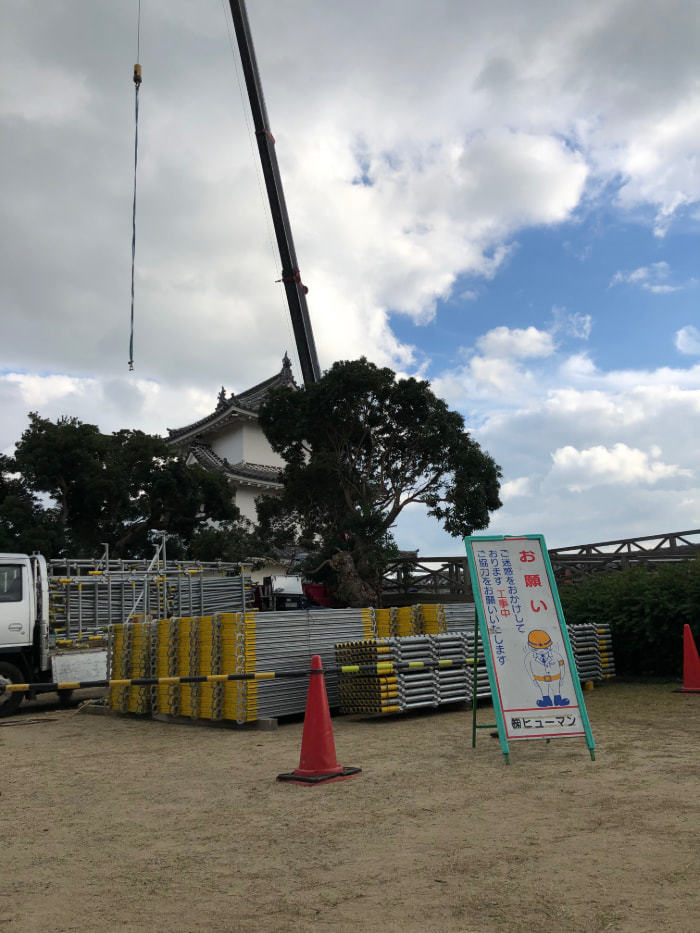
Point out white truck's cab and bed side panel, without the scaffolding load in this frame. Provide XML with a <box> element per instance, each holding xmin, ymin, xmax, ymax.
<box><xmin>0</xmin><ymin>554</ymin><xmax>107</xmax><ymax>716</ymax></box>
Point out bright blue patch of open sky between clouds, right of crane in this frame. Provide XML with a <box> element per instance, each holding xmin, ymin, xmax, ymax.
<box><xmin>393</xmin><ymin>217</ymin><xmax>700</xmax><ymax>373</ymax></box>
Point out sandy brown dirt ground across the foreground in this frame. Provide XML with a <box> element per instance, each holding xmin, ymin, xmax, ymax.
<box><xmin>0</xmin><ymin>682</ymin><xmax>700</xmax><ymax>933</ymax></box>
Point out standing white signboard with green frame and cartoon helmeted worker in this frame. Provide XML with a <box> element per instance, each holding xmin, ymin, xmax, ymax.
<box><xmin>465</xmin><ymin>535</ymin><xmax>595</xmax><ymax>758</ymax></box>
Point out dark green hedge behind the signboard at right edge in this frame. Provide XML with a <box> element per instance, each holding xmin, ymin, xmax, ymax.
<box><xmin>559</xmin><ymin>560</ymin><xmax>700</xmax><ymax>677</ymax></box>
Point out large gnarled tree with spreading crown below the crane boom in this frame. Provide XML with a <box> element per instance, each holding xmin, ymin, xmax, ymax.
<box><xmin>259</xmin><ymin>359</ymin><xmax>501</xmax><ymax>603</ymax></box>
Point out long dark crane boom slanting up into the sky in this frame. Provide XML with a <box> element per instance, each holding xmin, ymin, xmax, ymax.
<box><xmin>230</xmin><ymin>0</ymin><xmax>321</xmax><ymax>385</ymax></box>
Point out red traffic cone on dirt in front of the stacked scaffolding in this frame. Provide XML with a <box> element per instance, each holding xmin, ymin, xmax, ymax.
<box><xmin>277</xmin><ymin>654</ymin><xmax>362</xmax><ymax>786</ymax></box>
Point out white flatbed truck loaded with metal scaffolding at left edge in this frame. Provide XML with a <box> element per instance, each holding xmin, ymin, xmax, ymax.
<box><xmin>0</xmin><ymin>552</ymin><xmax>253</xmax><ymax>716</ymax></box>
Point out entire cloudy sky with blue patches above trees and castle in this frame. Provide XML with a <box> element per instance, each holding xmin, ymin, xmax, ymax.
<box><xmin>0</xmin><ymin>0</ymin><xmax>700</xmax><ymax>556</ymax></box>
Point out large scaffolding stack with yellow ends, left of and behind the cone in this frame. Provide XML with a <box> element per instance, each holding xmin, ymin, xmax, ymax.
<box><xmin>108</xmin><ymin>609</ymin><xmax>372</xmax><ymax>723</ymax></box>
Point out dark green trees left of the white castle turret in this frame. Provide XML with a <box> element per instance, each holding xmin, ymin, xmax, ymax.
<box><xmin>9</xmin><ymin>412</ymin><xmax>246</xmax><ymax>556</ymax></box>
